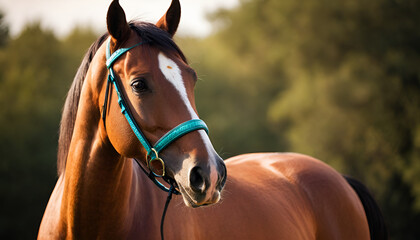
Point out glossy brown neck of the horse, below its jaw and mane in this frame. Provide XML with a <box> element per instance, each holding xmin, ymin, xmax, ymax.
<box><xmin>61</xmin><ymin>69</ymin><xmax>158</xmax><ymax>239</ymax></box>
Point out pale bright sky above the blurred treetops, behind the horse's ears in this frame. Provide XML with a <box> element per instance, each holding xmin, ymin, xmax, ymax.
<box><xmin>0</xmin><ymin>0</ymin><xmax>239</xmax><ymax>37</ymax></box>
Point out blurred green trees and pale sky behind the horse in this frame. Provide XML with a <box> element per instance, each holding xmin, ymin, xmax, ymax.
<box><xmin>0</xmin><ymin>0</ymin><xmax>420</xmax><ymax>239</ymax></box>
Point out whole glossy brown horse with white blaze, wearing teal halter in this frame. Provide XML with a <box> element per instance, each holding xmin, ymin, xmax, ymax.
<box><xmin>38</xmin><ymin>0</ymin><xmax>387</xmax><ymax>239</ymax></box>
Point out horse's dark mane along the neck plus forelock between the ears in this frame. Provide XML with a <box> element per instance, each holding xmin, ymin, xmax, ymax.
<box><xmin>57</xmin><ymin>21</ymin><xmax>187</xmax><ymax>176</ymax></box>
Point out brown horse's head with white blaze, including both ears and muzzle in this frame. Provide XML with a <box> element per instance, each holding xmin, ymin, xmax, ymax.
<box><xmin>97</xmin><ymin>0</ymin><xmax>226</xmax><ymax>207</ymax></box>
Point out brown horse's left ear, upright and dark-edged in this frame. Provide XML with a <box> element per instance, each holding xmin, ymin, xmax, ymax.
<box><xmin>106</xmin><ymin>0</ymin><xmax>130</xmax><ymax>44</ymax></box>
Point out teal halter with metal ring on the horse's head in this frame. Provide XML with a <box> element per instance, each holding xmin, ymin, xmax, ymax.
<box><xmin>102</xmin><ymin>39</ymin><xmax>208</xmax><ymax>194</ymax></box>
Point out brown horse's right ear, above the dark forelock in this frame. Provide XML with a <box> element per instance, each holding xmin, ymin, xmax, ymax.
<box><xmin>156</xmin><ymin>0</ymin><xmax>181</xmax><ymax>36</ymax></box>
